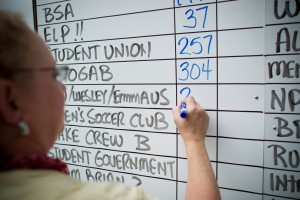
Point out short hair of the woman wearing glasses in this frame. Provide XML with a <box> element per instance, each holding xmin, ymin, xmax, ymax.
<box><xmin>0</xmin><ymin>10</ymin><xmax>32</xmax><ymax>78</ymax></box>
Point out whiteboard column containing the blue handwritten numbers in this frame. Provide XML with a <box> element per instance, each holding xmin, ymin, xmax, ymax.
<box><xmin>175</xmin><ymin>0</ymin><xmax>217</xmax><ymax>199</ymax></box>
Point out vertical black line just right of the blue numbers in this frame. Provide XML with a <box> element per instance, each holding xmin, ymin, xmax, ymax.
<box><xmin>216</xmin><ymin>0</ymin><xmax>219</xmax><ymax>183</ymax></box>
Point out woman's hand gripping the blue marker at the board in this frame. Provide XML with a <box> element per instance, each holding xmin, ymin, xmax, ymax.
<box><xmin>173</xmin><ymin>96</ymin><xmax>209</xmax><ymax>143</ymax></box>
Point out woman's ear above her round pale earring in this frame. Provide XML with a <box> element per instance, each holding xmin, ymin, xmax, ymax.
<box><xmin>0</xmin><ymin>79</ymin><xmax>22</xmax><ymax>125</ymax></box>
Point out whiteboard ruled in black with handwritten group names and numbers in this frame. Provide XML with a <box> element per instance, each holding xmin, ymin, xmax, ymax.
<box><xmin>36</xmin><ymin>0</ymin><xmax>300</xmax><ymax>200</ymax></box>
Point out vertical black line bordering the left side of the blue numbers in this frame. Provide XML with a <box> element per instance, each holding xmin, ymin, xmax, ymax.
<box><xmin>173</xmin><ymin>0</ymin><xmax>179</xmax><ymax>200</ymax></box>
